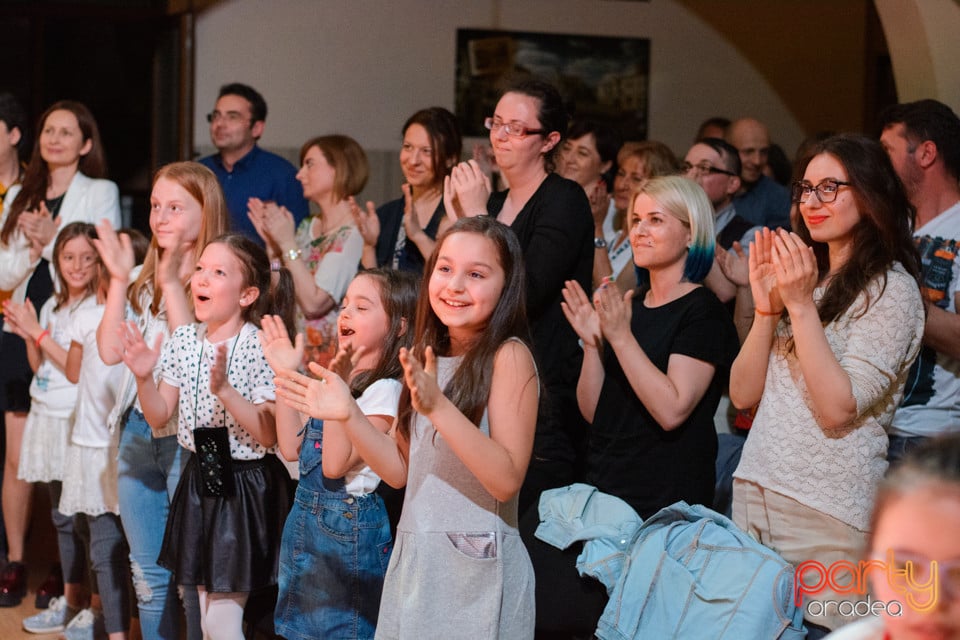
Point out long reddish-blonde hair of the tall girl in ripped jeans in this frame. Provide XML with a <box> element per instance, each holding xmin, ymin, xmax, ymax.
<box><xmin>127</xmin><ymin>162</ymin><xmax>230</xmax><ymax>315</ymax></box>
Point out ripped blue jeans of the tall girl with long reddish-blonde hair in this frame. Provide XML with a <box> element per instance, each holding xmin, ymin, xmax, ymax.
<box><xmin>117</xmin><ymin>409</ymin><xmax>203</xmax><ymax>640</ymax></box>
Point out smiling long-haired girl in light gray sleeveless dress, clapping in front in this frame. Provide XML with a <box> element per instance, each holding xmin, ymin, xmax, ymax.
<box><xmin>277</xmin><ymin>216</ymin><xmax>539</xmax><ymax>640</ymax></box>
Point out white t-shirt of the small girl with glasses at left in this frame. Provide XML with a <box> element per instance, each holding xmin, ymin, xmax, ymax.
<box><xmin>30</xmin><ymin>296</ymin><xmax>97</xmax><ymax>418</ymax></box>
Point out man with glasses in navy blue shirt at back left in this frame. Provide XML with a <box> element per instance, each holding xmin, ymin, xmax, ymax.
<box><xmin>200</xmin><ymin>82</ymin><xmax>309</xmax><ymax>245</ymax></box>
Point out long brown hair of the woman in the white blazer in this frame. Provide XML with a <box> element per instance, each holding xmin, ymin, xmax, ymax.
<box><xmin>0</xmin><ymin>100</ymin><xmax>107</xmax><ymax>244</ymax></box>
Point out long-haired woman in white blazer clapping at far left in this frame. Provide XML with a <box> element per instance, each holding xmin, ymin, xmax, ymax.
<box><xmin>0</xmin><ymin>100</ymin><xmax>120</xmax><ymax>606</ymax></box>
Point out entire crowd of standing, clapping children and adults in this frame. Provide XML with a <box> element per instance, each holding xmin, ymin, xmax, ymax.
<box><xmin>0</xmin><ymin>80</ymin><xmax>960</xmax><ymax>640</ymax></box>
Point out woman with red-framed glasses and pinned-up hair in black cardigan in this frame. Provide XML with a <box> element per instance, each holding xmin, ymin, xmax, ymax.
<box><xmin>444</xmin><ymin>80</ymin><xmax>596</xmax><ymax>533</ymax></box>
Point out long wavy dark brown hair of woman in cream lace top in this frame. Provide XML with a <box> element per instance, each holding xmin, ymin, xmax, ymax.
<box><xmin>794</xmin><ymin>134</ymin><xmax>920</xmax><ymax>324</ymax></box>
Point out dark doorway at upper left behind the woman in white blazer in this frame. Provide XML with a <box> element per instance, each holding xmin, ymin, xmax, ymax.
<box><xmin>0</xmin><ymin>0</ymin><xmax>193</xmax><ymax>232</ymax></box>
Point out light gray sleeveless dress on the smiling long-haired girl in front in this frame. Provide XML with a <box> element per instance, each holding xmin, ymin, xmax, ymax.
<box><xmin>376</xmin><ymin>357</ymin><xmax>535</xmax><ymax>640</ymax></box>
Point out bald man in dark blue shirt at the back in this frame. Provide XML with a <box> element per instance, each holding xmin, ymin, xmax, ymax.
<box><xmin>726</xmin><ymin>118</ymin><xmax>790</xmax><ymax>229</ymax></box>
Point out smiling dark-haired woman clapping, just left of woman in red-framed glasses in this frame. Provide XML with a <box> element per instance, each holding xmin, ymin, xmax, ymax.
<box><xmin>353</xmin><ymin>107</ymin><xmax>462</xmax><ymax>275</ymax></box>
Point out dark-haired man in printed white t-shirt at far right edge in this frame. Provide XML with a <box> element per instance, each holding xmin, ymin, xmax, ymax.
<box><xmin>880</xmin><ymin>100</ymin><xmax>960</xmax><ymax>464</ymax></box>
